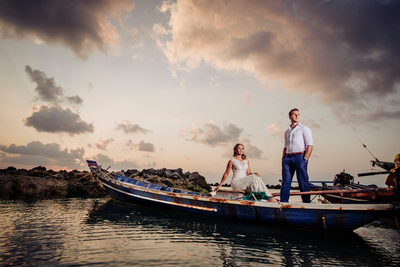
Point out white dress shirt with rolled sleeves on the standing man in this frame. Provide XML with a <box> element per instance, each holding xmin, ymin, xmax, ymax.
<box><xmin>285</xmin><ymin>123</ymin><xmax>314</xmax><ymax>154</ymax></box>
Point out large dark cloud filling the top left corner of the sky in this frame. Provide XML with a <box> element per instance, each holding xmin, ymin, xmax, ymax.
<box><xmin>0</xmin><ymin>0</ymin><xmax>134</xmax><ymax>59</ymax></box>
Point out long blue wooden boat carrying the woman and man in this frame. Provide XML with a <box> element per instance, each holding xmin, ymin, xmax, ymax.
<box><xmin>87</xmin><ymin>160</ymin><xmax>398</xmax><ymax>231</ymax></box>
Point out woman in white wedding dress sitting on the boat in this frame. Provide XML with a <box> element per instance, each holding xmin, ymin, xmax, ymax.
<box><xmin>215</xmin><ymin>144</ymin><xmax>278</xmax><ymax>202</ymax></box>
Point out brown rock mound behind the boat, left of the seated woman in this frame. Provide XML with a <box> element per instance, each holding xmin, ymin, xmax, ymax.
<box><xmin>124</xmin><ymin>168</ymin><xmax>212</xmax><ymax>193</ymax></box>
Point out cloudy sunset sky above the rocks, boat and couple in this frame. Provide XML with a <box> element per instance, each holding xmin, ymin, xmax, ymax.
<box><xmin>0</xmin><ymin>0</ymin><xmax>400</xmax><ymax>185</ymax></box>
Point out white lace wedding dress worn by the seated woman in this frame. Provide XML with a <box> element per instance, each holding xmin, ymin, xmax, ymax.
<box><xmin>231</xmin><ymin>158</ymin><xmax>272</xmax><ymax>197</ymax></box>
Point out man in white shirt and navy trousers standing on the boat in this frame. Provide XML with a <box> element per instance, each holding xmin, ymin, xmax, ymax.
<box><xmin>281</xmin><ymin>108</ymin><xmax>313</xmax><ymax>203</ymax></box>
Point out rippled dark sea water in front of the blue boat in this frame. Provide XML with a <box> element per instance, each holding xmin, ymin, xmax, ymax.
<box><xmin>0</xmin><ymin>198</ymin><xmax>400</xmax><ymax>266</ymax></box>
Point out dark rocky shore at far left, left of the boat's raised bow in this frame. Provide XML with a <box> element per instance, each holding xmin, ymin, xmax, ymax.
<box><xmin>0</xmin><ymin>166</ymin><xmax>107</xmax><ymax>200</ymax></box>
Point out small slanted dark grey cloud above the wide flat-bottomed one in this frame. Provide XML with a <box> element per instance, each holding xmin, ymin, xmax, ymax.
<box><xmin>25</xmin><ymin>66</ymin><xmax>64</xmax><ymax>103</ymax></box>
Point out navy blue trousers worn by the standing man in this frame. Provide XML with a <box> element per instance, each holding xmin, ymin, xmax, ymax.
<box><xmin>281</xmin><ymin>154</ymin><xmax>310</xmax><ymax>203</ymax></box>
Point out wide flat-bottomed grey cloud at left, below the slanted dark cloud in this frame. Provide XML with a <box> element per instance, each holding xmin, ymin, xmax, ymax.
<box><xmin>24</xmin><ymin>105</ymin><xmax>94</xmax><ymax>135</ymax></box>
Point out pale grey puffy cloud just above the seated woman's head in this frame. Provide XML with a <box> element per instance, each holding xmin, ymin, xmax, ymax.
<box><xmin>181</xmin><ymin>122</ymin><xmax>243</xmax><ymax>146</ymax></box>
